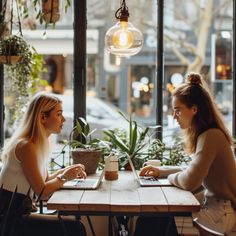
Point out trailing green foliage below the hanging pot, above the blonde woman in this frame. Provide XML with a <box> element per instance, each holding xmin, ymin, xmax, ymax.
<box><xmin>4</xmin><ymin>52</ymin><xmax>48</xmax><ymax>128</ymax></box>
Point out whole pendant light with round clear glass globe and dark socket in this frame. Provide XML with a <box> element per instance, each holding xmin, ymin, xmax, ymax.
<box><xmin>105</xmin><ymin>0</ymin><xmax>143</xmax><ymax>57</ymax></box>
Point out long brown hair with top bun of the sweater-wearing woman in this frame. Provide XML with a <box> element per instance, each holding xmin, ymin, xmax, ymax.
<box><xmin>172</xmin><ymin>72</ymin><xmax>233</xmax><ymax>154</ymax></box>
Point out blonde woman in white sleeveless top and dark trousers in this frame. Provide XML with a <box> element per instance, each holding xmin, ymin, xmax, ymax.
<box><xmin>0</xmin><ymin>92</ymin><xmax>86</xmax><ymax>236</ymax></box>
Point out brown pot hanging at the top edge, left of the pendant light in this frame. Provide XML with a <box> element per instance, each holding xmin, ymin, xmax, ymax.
<box><xmin>42</xmin><ymin>0</ymin><xmax>60</xmax><ymax>23</ymax></box>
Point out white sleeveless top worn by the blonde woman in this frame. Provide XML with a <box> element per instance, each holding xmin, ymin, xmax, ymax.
<box><xmin>0</xmin><ymin>144</ymin><xmax>47</xmax><ymax>198</ymax></box>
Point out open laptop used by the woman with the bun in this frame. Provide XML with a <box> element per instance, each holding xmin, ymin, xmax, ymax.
<box><xmin>128</xmin><ymin>156</ymin><xmax>171</xmax><ymax>187</ymax></box>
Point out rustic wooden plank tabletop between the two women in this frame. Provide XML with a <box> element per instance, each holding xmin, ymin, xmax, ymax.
<box><xmin>47</xmin><ymin>171</ymin><xmax>200</xmax><ymax>234</ymax></box>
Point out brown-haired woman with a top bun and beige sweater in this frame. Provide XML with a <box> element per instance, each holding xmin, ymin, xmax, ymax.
<box><xmin>137</xmin><ymin>73</ymin><xmax>236</xmax><ymax>235</ymax></box>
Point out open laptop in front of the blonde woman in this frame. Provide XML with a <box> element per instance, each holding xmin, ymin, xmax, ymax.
<box><xmin>62</xmin><ymin>169</ymin><xmax>105</xmax><ymax>190</ymax></box>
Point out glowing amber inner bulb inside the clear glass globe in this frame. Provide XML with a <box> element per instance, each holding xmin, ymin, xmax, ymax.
<box><xmin>112</xmin><ymin>21</ymin><xmax>134</xmax><ymax>49</ymax></box>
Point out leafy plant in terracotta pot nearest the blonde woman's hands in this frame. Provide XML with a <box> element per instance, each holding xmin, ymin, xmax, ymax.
<box><xmin>67</xmin><ymin>117</ymin><xmax>109</xmax><ymax>174</ymax></box>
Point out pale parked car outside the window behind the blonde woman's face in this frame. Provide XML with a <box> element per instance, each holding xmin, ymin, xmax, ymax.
<box><xmin>56</xmin><ymin>95</ymin><xmax>128</xmax><ymax>142</ymax></box>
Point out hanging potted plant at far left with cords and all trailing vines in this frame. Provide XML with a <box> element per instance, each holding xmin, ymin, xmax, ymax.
<box><xmin>0</xmin><ymin>0</ymin><xmax>48</xmax><ymax>130</ymax></box>
